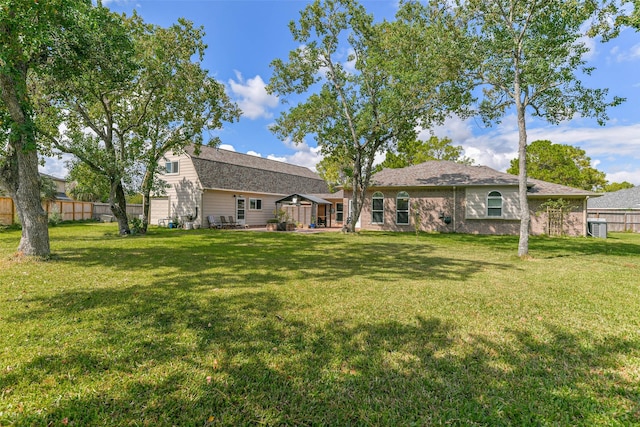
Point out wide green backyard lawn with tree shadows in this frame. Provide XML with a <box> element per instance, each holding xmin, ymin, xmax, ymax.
<box><xmin>0</xmin><ymin>224</ymin><xmax>640</xmax><ymax>426</ymax></box>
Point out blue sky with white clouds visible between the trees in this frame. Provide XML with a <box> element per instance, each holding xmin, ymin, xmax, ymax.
<box><xmin>43</xmin><ymin>0</ymin><xmax>640</xmax><ymax>185</ymax></box>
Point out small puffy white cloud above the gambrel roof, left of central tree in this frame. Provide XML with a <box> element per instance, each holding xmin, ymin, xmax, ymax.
<box><xmin>229</xmin><ymin>71</ymin><xmax>278</xmax><ymax>119</ymax></box>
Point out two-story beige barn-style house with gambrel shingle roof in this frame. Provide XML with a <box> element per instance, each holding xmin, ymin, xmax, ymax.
<box><xmin>149</xmin><ymin>146</ymin><xmax>328</xmax><ymax>227</ymax></box>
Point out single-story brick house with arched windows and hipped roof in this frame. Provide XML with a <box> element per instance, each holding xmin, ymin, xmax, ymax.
<box><xmin>347</xmin><ymin>161</ymin><xmax>597</xmax><ymax>236</ymax></box>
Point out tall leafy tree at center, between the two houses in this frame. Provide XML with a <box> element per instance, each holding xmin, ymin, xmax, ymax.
<box><xmin>268</xmin><ymin>0</ymin><xmax>464</xmax><ymax>231</ymax></box>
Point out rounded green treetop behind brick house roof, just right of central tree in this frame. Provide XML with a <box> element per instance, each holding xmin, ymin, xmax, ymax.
<box><xmin>376</xmin><ymin>136</ymin><xmax>473</xmax><ymax>170</ymax></box>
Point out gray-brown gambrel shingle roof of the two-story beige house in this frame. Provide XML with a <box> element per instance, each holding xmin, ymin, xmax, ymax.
<box><xmin>185</xmin><ymin>146</ymin><xmax>327</xmax><ymax>194</ymax></box>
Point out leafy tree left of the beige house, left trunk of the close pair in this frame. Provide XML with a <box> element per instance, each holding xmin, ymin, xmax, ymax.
<box><xmin>37</xmin><ymin>6</ymin><xmax>136</xmax><ymax>234</ymax></box>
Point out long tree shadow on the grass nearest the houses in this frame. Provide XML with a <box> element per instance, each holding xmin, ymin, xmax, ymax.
<box><xmin>46</xmin><ymin>232</ymin><xmax>514</xmax><ymax>287</ymax></box>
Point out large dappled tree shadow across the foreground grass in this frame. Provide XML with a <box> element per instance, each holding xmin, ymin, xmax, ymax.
<box><xmin>5</xmin><ymin>284</ymin><xmax>640</xmax><ymax>426</ymax></box>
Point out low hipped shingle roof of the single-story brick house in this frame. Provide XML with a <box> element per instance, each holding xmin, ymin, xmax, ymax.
<box><xmin>370</xmin><ymin>160</ymin><xmax>597</xmax><ymax>197</ymax></box>
